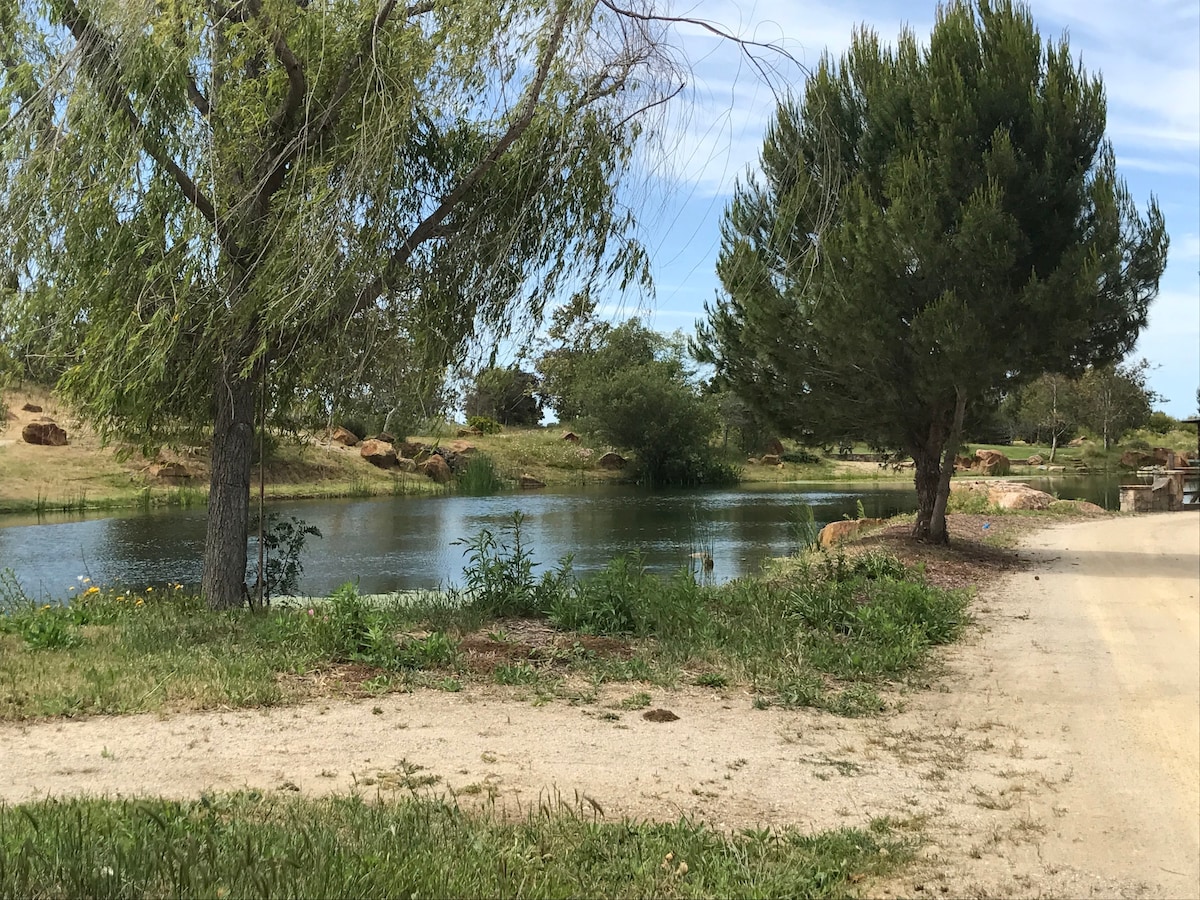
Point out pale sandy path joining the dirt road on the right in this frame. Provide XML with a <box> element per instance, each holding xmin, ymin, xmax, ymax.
<box><xmin>0</xmin><ymin>514</ymin><xmax>1200</xmax><ymax>898</ymax></box>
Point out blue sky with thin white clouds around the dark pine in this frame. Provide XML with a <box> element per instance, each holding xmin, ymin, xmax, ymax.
<box><xmin>619</xmin><ymin>0</ymin><xmax>1200</xmax><ymax>416</ymax></box>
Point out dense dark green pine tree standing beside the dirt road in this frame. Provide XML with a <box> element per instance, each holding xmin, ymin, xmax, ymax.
<box><xmin>696</xmin><ymin>0</ymin><xmax>1168</xmax><ymax>541</ymax></box>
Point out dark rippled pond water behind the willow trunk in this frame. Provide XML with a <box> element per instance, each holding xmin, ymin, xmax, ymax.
<box><xmin>0</xmin><ymin>478</ymin><xmax>1117</xmax><ymax>599</ymax></box>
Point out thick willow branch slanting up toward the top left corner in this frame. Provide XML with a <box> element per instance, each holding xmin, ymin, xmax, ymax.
<box><xmin>59</xmin><ymin>0</ymin><xmax>240</xmax><ymax>259</ymax></box>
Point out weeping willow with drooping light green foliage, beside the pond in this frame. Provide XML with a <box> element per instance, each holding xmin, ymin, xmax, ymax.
<box><xmin>0</xmin><ymin>0</ymin><xmax>696</xmax><ymax>607</ymax></box>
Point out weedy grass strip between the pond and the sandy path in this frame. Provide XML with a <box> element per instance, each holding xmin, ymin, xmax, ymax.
<box><xmin>0</xmin><ymin>522</ymin><xmax>966</xmax><ymax>720</ymax></box>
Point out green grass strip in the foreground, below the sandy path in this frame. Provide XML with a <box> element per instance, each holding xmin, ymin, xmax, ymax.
<box><xmin>0</xmin><ymin>793</ymin><xmax>912</xmax><ymax>898</ymax></box>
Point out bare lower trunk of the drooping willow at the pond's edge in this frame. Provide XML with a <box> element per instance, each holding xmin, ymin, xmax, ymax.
<box><xmin>200</xmin><ymin>365</ymin><xmax>254</xmax><ymax>610</ymax></box>
